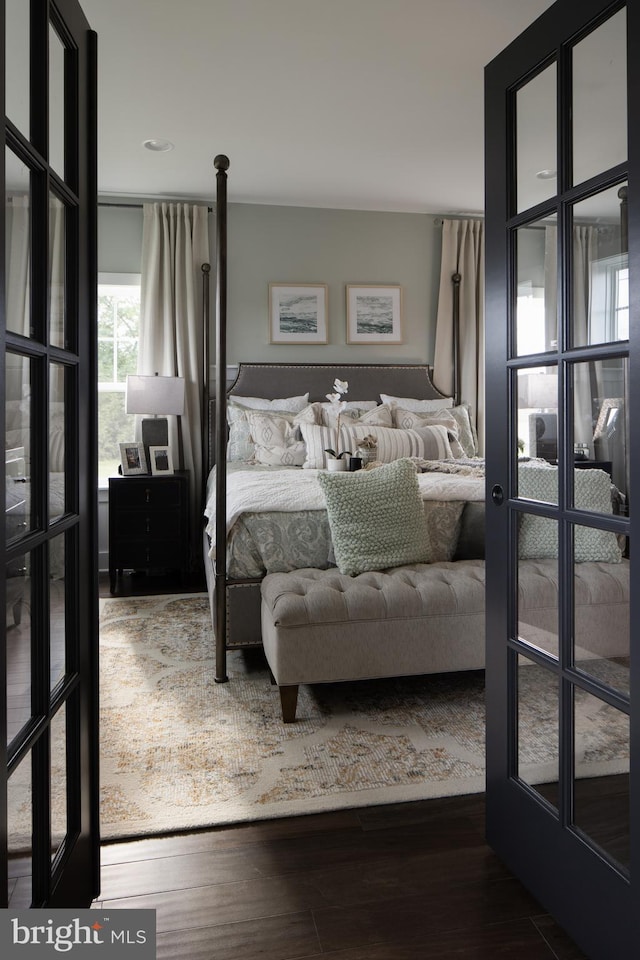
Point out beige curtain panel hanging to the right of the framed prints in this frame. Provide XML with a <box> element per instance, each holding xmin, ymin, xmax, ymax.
<box><xmin>433</xmin><ymin>220</ymin><xmax>485</xmax><ymax>454</ymax></box>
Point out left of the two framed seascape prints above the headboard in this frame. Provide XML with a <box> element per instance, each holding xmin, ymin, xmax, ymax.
<box><xmin>269</xmin><ymin>283</ymin><xmax>328</xmax><ymax>343</ymax></box>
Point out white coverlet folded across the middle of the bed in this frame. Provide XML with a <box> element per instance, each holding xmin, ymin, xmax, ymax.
<box><xmin>205</xmin><ymin>470</ymin><xmax>485</xmax><ymax>556</ymax></box>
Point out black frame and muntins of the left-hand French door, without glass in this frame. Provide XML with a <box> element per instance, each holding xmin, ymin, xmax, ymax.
<box><xmin>0</xmin><ymin>0</ymin><xmax>100</xmax><ymax>907</ymax></box>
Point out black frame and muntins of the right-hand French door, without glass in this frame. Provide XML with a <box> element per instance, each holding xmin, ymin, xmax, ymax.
<box><xmin>485</xmin><ymin>0</ymin><xmax>640</xmax><ymax>960</ymax></box>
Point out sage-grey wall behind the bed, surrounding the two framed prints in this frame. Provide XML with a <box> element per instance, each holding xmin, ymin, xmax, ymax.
<box><xmin>98</xmin><ymin>203</ymin><xmax>442</xmax><ymax>364</ymax></box>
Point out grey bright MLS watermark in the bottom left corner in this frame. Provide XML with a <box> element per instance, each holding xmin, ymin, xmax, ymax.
<box><xmin>0</xmin><ymin>908</ymin><xmax>156</xmax><ymax>960</ymax></box>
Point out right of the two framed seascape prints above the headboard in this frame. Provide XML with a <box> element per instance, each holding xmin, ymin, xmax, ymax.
<box><xmin>347</xmin><ymin>283</ymin><xmax>402</xmax><ymax>343</ymax></box>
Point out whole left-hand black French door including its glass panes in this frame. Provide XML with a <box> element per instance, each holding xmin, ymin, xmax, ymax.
<box><xmin>0</xmin><ymin>0</ymin><xmax>99</xmax><ymax>908</ymax></box>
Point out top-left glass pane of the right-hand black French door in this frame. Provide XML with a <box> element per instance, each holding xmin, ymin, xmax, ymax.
<box><xmin>516</xmin><ymin>63</ymin><xmax>557</xmax><ymax>211</ymax></box>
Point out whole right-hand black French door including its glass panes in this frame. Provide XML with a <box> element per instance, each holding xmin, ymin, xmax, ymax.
<box><xmin>485</xmin><ymin>0</ymin><xmax>640</xmax><ymax>960</ymax></box>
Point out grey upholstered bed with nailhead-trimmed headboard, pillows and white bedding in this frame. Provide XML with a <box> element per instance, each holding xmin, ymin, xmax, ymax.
<box><xmin>204</xmin><ymin>363</ymin><xmax>484</xmax><ymax>679</ymax></box>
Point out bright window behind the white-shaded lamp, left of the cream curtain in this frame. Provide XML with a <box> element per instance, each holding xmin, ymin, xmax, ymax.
<box><xmin>98</xmin><ymin>273</ymin><xmax>140</xmax><ymax>486</ymax></box>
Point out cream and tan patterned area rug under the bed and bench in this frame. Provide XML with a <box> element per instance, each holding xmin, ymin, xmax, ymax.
<box><xmin>100</xmin><ymin>595</ymin><xmax>628</xmax><ymax>839</ymax></box>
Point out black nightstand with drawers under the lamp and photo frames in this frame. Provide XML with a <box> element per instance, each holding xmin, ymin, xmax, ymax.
<box><xmin>109</xmin><ymin>470</ymin><xmax>189</xmax><ymax>593</ymax></box>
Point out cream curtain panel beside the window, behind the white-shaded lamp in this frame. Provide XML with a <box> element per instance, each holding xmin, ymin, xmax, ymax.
<box><xmin>138</xmin><ymin>203</ymin><xmax>209</xmax><ymax>564</ymax></box>
